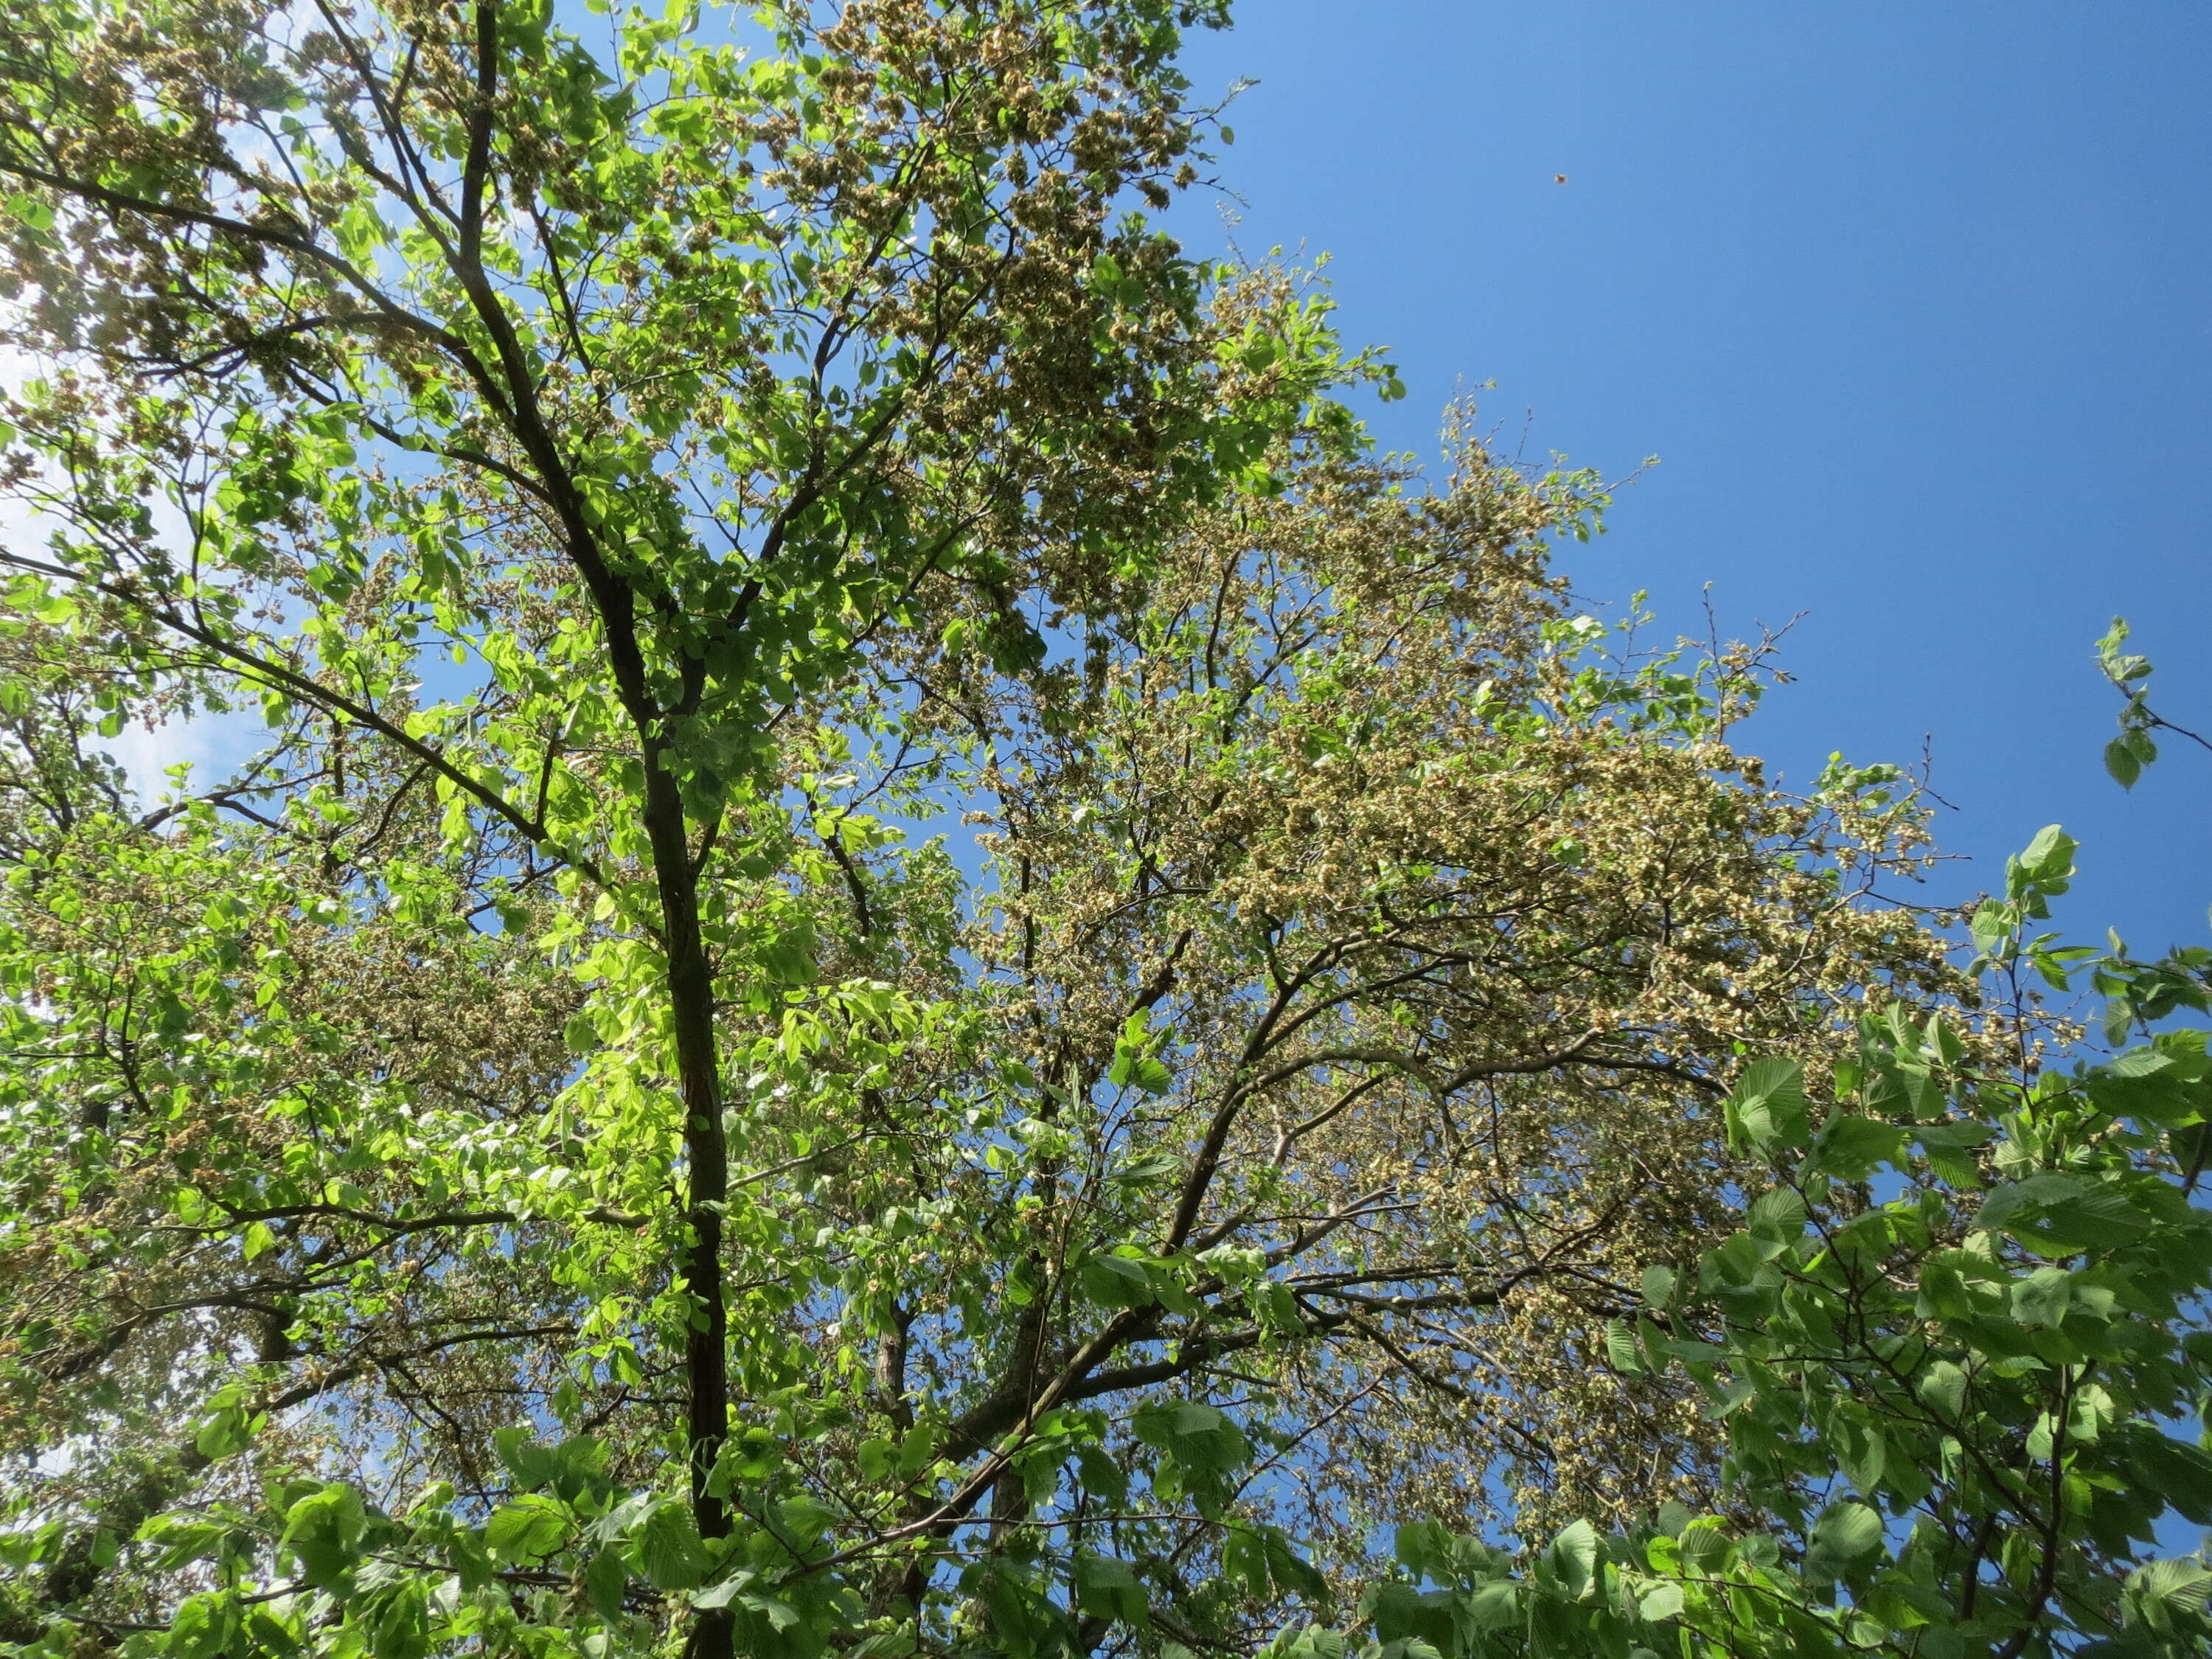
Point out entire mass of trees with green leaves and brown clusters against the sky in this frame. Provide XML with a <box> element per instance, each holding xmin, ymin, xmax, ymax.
<box><xmin>0</xmin><ymin>0</ymin><xmax>2212</xmax><ymax>1659</ymax></box>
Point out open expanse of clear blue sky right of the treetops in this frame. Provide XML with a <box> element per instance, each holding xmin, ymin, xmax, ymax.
<box><xmin>1177</xmin><ymin>0</ymin><xmax>2212</xmax><ymax>973</ymax></box>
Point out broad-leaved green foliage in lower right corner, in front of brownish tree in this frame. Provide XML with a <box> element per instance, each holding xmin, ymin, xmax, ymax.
<box><xmin>1276</xmin><ymin>832</ymin><xmax>2212</xmax><ymax>1659</ymax></box>
